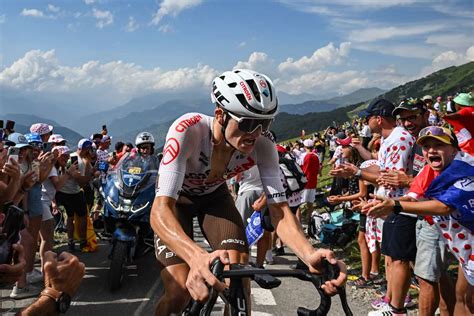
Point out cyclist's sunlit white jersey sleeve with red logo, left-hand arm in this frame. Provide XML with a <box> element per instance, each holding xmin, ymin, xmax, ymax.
<box><xmin>156</xmin><ymin>114</ymin><xmax>201</xmax><ymax>199</ymax></box>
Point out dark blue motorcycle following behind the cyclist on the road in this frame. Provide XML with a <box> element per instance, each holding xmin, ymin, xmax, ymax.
<box><xmin>99</xmin><ymin>155</ymin><xmax>158</xmax><ymax>291</ymax></box>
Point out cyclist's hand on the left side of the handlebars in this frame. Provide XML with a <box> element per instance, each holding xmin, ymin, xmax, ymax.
<box><xmin>186</xmin><ymin>250</ymin><xmax>230</xmax><ymax>302</ymax></box>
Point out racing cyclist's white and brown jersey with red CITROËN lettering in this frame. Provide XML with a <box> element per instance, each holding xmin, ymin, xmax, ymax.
<box><xmin>156</xmin><ymin>113</ymin><xmax>286</xmax><ymax>204</ymax></box>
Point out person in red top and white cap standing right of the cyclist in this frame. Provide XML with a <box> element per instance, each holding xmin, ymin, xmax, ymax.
<box><xmin>296</xmin><ymin>139</ymin><xmax>321</xmax><ymax>223</ymax></box>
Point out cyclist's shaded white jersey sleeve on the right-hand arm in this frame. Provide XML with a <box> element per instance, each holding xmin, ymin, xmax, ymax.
<box><xmin>256</xmin><ymin>135</ymin><xmax>286</xmax><ymax>204</ymax></box>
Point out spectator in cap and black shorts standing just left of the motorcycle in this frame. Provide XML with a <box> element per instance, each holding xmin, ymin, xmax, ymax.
<box><xmin>56</xmin><ymin>138</ymin><xmax>92</xmax><ymax>251</ymax></box>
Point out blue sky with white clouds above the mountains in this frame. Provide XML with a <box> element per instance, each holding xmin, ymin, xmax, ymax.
<box><xmin>0</xmin><ymin>0</ymin><xmax>474</xmax><ymax>107</ymax></box>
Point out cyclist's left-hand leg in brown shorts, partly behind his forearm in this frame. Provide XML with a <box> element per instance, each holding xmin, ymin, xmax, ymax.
<box><xmin>155</xmin><ymin>196</ymin><xmax>194</xmax><ymax>315</ymax></box>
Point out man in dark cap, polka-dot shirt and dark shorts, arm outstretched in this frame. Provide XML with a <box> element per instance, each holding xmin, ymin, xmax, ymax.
<box><xmin>330</xmin><ymin>99</ymin><xmax>417</xmax><ymax>315</ymax></box>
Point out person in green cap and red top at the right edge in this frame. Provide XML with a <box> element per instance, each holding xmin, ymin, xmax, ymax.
<box><xmin>443</xmin><ymin>92</ymin><xmax>474</xmax><ymax>155</ymax></box>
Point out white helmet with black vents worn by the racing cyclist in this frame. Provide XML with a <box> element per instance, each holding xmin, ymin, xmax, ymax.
<box><xmin>211</xmin><ymin>69</ymin><xmax>278</xmax><ymax>119</ymax></box>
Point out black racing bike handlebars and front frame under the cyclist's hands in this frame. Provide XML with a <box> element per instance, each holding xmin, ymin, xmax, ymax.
<box><xmin>184</xmin><ymin>261</ymin><xmax>352</xmax><ymax>316</ymax></box>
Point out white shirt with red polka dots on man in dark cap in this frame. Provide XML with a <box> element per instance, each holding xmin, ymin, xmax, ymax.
<box><xmin>376</xmin><ymin>126</ymin><xmax>416</xmax><ymax>216</ymax></box>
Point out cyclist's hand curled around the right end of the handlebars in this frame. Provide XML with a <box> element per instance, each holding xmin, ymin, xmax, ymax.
<box><xmin>308</xmin><ymin>249</ymin><xmax>347</xmax><ymax>295</ymax></box>
